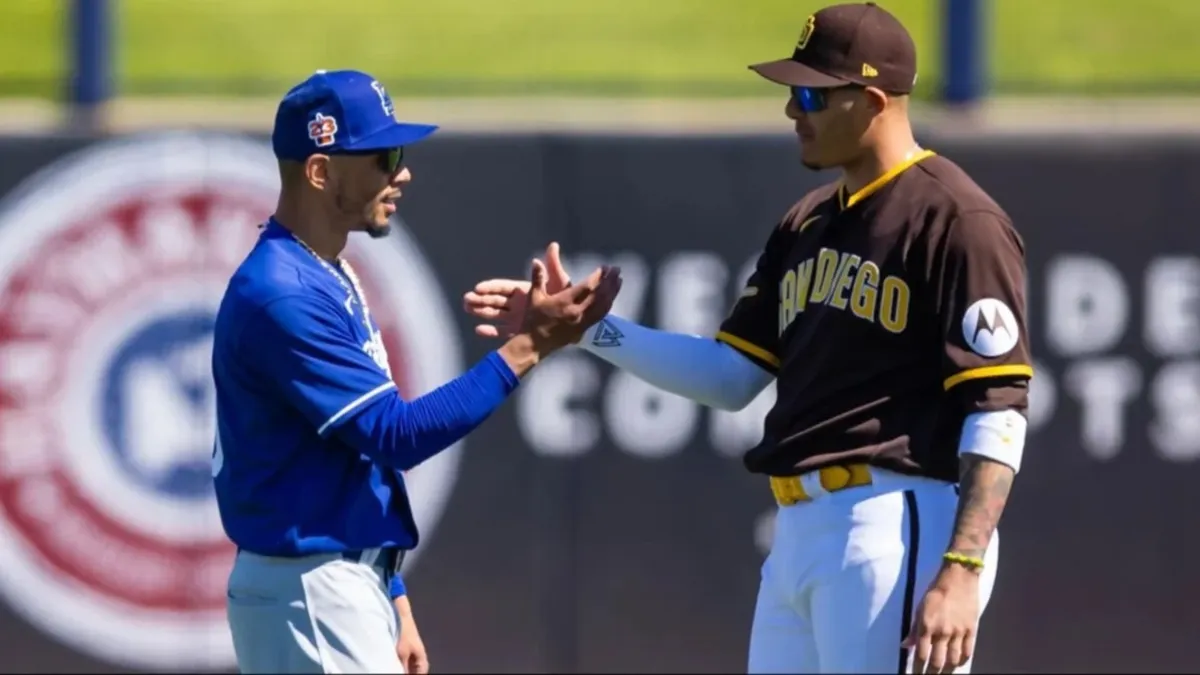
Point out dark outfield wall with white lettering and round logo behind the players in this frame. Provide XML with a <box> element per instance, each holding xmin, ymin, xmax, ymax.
<box><xmin>0</xmin><ymin>135</ymin><xmax>1200</xmax><ymax>673</ymax></box>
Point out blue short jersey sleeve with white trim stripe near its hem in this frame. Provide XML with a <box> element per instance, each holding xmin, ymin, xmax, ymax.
<box><xmin>242</xmin><ymin>295</ymin><xmax>396</xmax><ymax>436</ymax></box>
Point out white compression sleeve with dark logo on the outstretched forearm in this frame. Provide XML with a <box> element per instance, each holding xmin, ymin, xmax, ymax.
<box><xmin>580</xmin><ymin>315</ymin><xmax>774</xmax><ymax>411</ymax></box>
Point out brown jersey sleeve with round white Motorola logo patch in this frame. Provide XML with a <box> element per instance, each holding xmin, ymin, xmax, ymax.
<box><xmin>932</xmin><ymin>211</ymin><xmax>1033</xmax><ymax>414</ymax></box>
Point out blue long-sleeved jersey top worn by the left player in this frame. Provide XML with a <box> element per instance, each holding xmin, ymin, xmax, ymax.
<box><xmin>212</xmin><ymin>220</ymin><xmax>518</xmax><ymax>556</ymax></box>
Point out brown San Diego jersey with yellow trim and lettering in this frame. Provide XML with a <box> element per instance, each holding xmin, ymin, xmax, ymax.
<box><xmin>716</xmin><ymin>151</ymin><xmax>1033</xmax><ymax>482</ymax></box>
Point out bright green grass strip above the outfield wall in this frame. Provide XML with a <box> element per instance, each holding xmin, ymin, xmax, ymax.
<box><xmin>0</xmin><ymin>0</ymin><xmax>1200</xmax><ymax>97</ymax></box>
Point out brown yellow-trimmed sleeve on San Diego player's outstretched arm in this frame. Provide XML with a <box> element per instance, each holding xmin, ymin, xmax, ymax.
<box><xmin>716</xmin><ymin>227</ymin><xmax>782</xmax><ymax>375</ymax></box>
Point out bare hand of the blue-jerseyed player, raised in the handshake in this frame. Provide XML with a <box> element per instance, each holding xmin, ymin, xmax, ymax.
<box><xmin>518</xmin><ymin>252</ymin><xmax>622</xmax><ymax>356</ymax></box>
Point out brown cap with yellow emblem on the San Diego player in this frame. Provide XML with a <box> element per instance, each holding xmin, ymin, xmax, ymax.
<box><xmin>750</xmin><ymin>2</ymin><xmax>917</xmax><ymax>94</ymax></box>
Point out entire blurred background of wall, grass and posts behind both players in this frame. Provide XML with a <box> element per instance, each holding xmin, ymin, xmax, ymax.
<box><xmin>0</xmin><ymin>0</ymin><xmax>1200</xmax><ymax>673</ymax></box>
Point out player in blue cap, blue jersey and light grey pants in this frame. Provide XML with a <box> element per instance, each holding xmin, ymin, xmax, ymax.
<box><xmin>212</xmin><ymin>71</ymin><xmax>620</xmax><ymax>673</ymax></box>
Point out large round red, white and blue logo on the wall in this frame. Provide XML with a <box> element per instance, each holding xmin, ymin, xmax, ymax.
<box><xmin>0</xmin><ymin>133</ymin><xmax>462</xmax><ymax>670</ymax></box>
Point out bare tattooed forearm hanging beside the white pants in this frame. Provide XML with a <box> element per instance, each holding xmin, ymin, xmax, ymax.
<box><xmin>950</xmin><ymin>454</ymin><xmax>1013</xmax><ymax>557</ymax></box>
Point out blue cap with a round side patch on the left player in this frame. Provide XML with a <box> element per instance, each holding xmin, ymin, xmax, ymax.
<box><xmin>271</xmin><ymin>71</ymin><xmax>438</xmax><ymax>161</ymax></box>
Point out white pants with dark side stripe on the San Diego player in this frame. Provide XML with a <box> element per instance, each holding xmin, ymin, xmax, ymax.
<box><xmin>749</xmin><ymin>467</ymin><xmax>1000</xmax><ymax>674</ymax></box>
